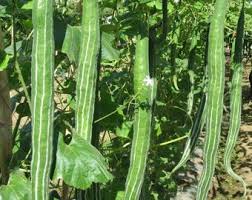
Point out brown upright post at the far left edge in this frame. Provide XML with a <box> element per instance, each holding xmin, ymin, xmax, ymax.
<box><xmin>0</xmin><ymin>27</ymin><xmax>12</xmax><ymax>184</ymax></box>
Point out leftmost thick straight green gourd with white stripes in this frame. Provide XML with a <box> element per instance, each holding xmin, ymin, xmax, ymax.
<box><xmin>31</xmin><ymin>0</ymin><xmax>54</xmax><ymax>200</ymax></box>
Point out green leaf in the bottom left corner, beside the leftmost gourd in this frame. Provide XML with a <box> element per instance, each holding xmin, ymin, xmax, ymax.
<box><xmin>0</xmin><ymin>170</ymin><xmax>31</xmax><ymax>200</ymax></box>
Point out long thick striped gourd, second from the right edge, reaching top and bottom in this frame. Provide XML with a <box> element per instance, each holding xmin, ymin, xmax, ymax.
<box><xmin>196</xmin><ymin>0</ymin><xmax>229</xmax><ymax>200</ymax></box>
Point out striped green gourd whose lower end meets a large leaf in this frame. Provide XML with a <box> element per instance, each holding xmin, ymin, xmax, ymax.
<box><xmin>76</xmin><ymin>0</ymin><xmax>100</xmax><ymax>142</ymax></box>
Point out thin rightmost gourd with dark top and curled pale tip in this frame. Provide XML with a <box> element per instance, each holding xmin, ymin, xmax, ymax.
<box><xmin>224</xmin><ymin>1</ymin><xmax>246</xmax><ymax>196</ymax></box>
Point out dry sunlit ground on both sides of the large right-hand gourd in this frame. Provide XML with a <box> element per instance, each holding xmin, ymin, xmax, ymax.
<box><xmin>175</xmin><ymin>59</ymin><xmax>252</xmax><ymax>200</ymax></box>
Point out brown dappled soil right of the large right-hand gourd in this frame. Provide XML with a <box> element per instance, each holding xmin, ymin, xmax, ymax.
<box><xmin>210</xmin><ymin>59</ymin><xmax>252</xmax><ymax>200</ymax></box>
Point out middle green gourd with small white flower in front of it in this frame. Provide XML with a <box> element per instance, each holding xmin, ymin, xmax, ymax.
<box><xmin>124</xmin><ymin>28</ymin><xmax>155</xmax><ymax>200</ymax></box>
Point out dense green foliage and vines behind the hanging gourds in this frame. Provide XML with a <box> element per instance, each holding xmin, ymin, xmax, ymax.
<box><xmin>0</xmin><ymin>0</ymin><xmax>252</xmax><ymax>200</ymax></box>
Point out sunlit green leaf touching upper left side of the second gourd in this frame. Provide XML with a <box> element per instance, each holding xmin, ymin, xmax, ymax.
<box><xmin>62</xmin><ymin>25</ymin><xmax>81</xmax><ymax>63</ymax></box>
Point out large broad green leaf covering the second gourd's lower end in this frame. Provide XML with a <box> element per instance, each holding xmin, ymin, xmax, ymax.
<box><xmin>54</xmin><ymin>134</ymin><xmax>113</xmax><ymax>189</ymax></box>
